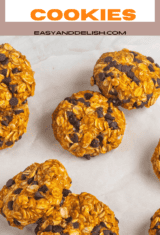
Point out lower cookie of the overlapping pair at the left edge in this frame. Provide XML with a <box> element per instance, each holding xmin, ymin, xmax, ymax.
<box><xmin>0</xmin><ymin>102</ymin><xmax>29</xmax><ymax>150</ymax></box>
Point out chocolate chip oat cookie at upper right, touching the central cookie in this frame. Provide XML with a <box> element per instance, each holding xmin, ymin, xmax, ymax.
<box><xmin>91</xmin><ymin>49</ymin><xmax>160</xmax><ymax>110</ymax></box>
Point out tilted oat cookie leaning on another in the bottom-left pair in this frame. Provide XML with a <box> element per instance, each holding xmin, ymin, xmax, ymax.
<box><xmin>0</xmin><ymin>160</ymin><xmax>71</xmax><ymax>229</ymax></box>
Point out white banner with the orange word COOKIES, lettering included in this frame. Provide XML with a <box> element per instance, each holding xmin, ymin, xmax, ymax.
<box><xmin>5</xmin><ymin>0</ymin><xmax>155</xmax><ymax>22</ymax></box>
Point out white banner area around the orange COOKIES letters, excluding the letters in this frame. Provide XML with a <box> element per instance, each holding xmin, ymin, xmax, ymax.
<box><xmin>5</xmin><ymin>0</ymin><xmax>155</xmax><ymax>22</ymax></box>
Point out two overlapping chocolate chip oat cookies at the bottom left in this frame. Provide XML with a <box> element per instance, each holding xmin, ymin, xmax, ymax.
<box><xmin>0</xmin><ymin>160</ymin><xmax>119</xmax><ymax>235</ymax></box>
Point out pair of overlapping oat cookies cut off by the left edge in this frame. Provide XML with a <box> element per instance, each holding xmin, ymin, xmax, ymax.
<box><xmin>0</xmin><ymin>43</ymin><xmax>35</xmax><ymax>150</ymax></box>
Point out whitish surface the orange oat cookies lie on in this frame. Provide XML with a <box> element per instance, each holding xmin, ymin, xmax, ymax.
<box><xmin>0</xmin><ymin>36</ymin><xmax>160</xmax><ymax>235</ymax></box>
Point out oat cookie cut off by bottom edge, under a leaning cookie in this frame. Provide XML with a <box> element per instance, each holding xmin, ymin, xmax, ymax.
<box><xmin>35</xmin><ymin>193</ymin><xmax>119</xmax><ymax>235</ymax></box>
